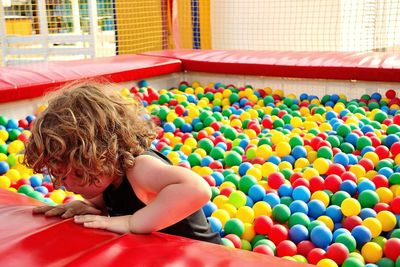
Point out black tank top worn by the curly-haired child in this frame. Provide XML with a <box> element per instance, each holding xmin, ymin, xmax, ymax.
<box><xmin>103</xmin><ymin>150</ymin><xmax>222</xmax><ymax>244</ymax></box>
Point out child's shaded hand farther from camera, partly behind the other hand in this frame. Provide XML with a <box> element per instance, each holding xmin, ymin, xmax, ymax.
<box><xmin>33</xmin><ymin>200</ymin><xmax>102</xmax><ymax>219</ymax></box>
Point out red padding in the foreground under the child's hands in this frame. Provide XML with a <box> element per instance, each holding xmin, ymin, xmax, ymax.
<box><xmin>0</xmin><ymin>189</ymin><xmax>310</xmax><ymax>267</ymax></box>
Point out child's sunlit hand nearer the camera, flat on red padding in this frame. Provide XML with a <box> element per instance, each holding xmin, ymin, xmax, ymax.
<box><xmin>74</xmin><ymin>215</ymin><xmax>130</xmax><ymax>234</ymax></box>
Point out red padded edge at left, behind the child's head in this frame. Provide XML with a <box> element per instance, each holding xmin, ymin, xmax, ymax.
<box><xmin>0</xmin><ymin>55</ymin><xmax>182</xmax><ymax>103</ymax></box>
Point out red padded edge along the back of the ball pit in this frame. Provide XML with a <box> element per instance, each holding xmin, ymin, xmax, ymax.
<box><xmin>143</xmin><ymin>49</ymin><xmax>400</xmax><ymax>82</ymax></box>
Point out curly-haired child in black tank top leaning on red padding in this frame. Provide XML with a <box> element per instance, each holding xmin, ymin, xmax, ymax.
<box><xmin>24</xmin><ymin>83</ymin><xmax>221</xmax><ymax>244</ymax></box>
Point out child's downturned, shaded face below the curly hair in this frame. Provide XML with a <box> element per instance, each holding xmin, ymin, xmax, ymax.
<box><xmin>52</xmin><ymin>171</ymin><xmax>113</xmax><ymax>199</ymax></box>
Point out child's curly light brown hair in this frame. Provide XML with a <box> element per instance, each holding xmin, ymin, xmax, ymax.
<box><xmin>24</xmin><ymin>81</ymin><xmax>156</xmax><ymax>187</ymax></box>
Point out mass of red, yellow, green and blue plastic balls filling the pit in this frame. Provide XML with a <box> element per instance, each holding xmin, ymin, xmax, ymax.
<box><xmin>0</xmin><ymin>82</ymin><xmax>400</xmax><ymax>266</ymax></box>
